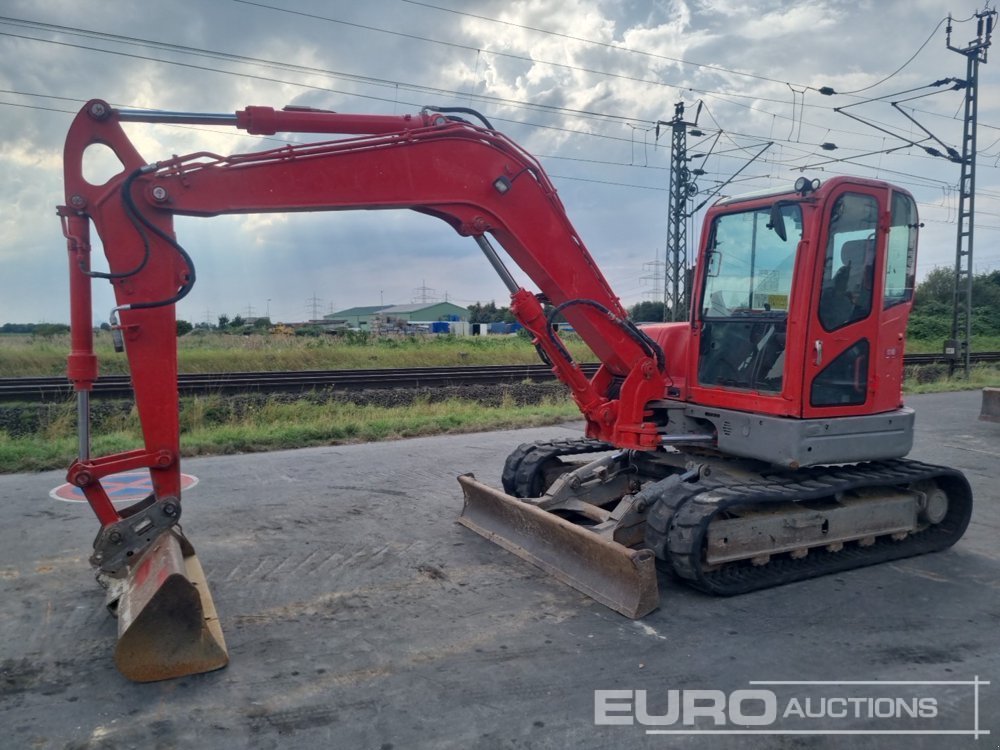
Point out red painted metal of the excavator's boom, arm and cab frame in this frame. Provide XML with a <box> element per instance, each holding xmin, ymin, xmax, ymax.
<box><xmin>59</xmin><ymin>100</ymin><xmax>909</xmax><ymax>525</ymax></box>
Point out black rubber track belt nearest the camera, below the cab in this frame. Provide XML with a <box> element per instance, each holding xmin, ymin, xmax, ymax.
<box><xmin>646</xmin><ymin>460</ymin><xmax>972</xmax><ymax>596</ymax></box>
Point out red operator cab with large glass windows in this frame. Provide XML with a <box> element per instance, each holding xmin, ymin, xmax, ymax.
<box><xmin>689</xmin><ymin>177</ymin><xmax>918</xmax><ymax>417</ymax></box>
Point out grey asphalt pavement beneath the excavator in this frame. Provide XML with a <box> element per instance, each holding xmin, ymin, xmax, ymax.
<box><xmin>0</xmin><ymin>392</ymin><xmax>1000</xmax><ymax>750</ymax></box>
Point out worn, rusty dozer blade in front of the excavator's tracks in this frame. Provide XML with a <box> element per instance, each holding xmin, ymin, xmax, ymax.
<box><xmin>458</xmin><ymin>474</ymin><xmax>660</xmax><ymax>619</ymax></box>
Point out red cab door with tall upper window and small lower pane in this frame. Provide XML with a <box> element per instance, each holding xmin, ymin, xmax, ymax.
<box><xmin>802</xmin><ymin>183</ymin><xmax>905</xmax><ymax>417</ymax></box>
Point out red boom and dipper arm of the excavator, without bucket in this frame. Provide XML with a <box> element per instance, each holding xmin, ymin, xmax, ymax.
<box><xmin>60</xmin><ymin>100</ymin><xmax>665</xmax><ymax>525</ymax></box>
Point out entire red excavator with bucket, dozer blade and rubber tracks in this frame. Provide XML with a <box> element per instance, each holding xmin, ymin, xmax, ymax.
<box><xmin>58</xmin><ymin>100</ymin><xmax>972</xmax><ymax>681</ymax></box>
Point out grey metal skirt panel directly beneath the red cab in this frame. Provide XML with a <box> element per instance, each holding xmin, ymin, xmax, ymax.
<box><xmin>684</xmin><ymin>406</ymin><xmax>914</xmax><ymax>468</ymax></box>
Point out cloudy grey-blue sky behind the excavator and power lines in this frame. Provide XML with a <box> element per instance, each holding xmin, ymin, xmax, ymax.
<box><xmin>0</xmin><ymin>0</ymin><xmax>1000</xmax><ymax>323</ymax></box>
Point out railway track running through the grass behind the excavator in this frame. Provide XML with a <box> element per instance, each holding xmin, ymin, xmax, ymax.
<box><xmin>0</xmin><ymin>352</ymin><xmax>1000</xmax><ymax>401</ymax></box>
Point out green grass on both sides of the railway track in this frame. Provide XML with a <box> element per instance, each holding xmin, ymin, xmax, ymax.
<box><xmin>0</xmin><ymin>335</ymin><xmax>1000</xmax><ymax>473</ymax></box>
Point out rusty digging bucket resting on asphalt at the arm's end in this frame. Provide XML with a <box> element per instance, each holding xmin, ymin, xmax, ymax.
<box><xmin>111</xmin><ymin>529</ymin><xmax>229</xmax><ymax>682</ymax></box>
